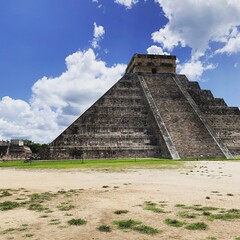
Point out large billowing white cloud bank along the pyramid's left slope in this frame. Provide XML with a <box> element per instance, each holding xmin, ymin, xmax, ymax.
<box><xmin>0</xmin><ymin>48</ymin><xmax>126</xmax><ymax>143</ymax></box>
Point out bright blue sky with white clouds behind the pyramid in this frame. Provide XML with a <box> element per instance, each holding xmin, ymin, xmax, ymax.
<box><xmin>0</xmin><ymin>0</ymin><xmax>240</xmax><ymax>143</ymax></box>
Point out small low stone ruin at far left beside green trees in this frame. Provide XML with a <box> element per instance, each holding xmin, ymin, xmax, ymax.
<box><xmin>0</xmin><ymin>139</ymin><xmax>32</xmax><ymax>160</ymax></box>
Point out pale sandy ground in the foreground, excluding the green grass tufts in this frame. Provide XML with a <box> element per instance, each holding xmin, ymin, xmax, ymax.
<box><xmin>0</xmin><ymin>161</ymin><xmax>240</xmax><ymax>240</ymax></box>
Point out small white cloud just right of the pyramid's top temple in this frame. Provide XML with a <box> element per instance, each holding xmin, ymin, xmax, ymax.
<box><xmin>177</xmin><ymin>60</ymin><xmax>216</xmax><ymax>81</ymax></box>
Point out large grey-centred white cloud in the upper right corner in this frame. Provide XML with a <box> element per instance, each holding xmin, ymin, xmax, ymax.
<box><xmin>152</xmin><ymin>0</ymin><xmax>240</xmax><ymax>60</ymax></box>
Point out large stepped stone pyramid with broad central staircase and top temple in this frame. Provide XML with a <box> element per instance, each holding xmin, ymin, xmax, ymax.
<box><xmin>43</xmin><ymin>54</ymin><xmax>240</xmax><ymax>159</ymax></box>
